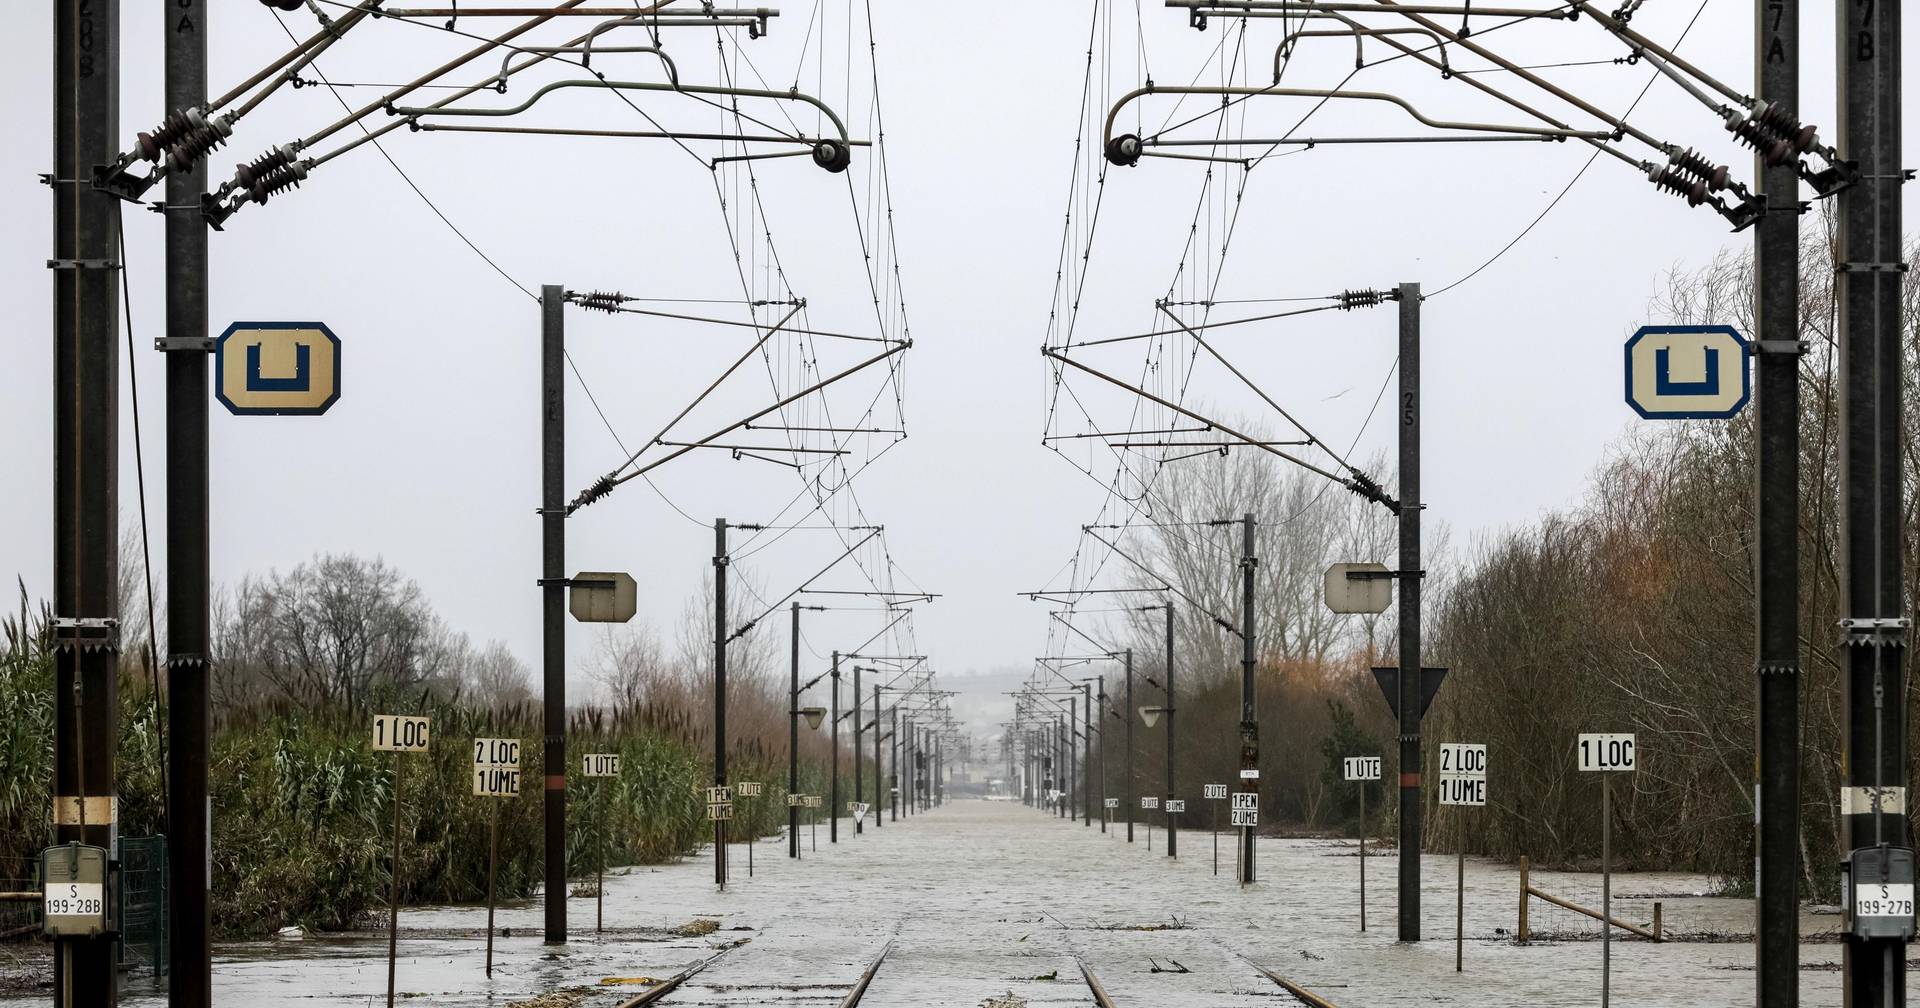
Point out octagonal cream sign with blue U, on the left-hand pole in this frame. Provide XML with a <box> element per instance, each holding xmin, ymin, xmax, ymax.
<box><xmin>213</xmin><ymin>323</ymin><xmax>340</xmax><ymax>417</ymax></box>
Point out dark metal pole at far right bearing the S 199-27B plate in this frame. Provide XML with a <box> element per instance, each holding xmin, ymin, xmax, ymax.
<box><xmin>1834</xmin><ymin>0</ymin><xmax>1912</xmax><ymax>1008</ymax></box>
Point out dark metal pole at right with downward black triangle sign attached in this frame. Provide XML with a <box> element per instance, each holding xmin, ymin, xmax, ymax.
<box><xmin>1398</xmin><ymin>284</ymin><xmax>1425</xmax><ymax>941</ymax></box>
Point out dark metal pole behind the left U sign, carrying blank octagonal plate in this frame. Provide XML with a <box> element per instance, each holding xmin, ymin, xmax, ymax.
<box><xmin>540</xmin><ymin>284</ymin><xmax>566</xmax><ymax>945</ymax></box>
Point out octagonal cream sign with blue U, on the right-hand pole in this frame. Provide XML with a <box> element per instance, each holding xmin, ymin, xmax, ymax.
<box><xmin>1626</xmin><ymin>326</ymin><xmax>1753</xmax><ymax>420</ymax></box>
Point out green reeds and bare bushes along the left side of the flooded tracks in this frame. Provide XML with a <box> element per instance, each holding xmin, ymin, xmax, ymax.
<box><xmin>0</xmin><ymin>557</ymin><xmax>828</xmax><ymax>937</ymax></box>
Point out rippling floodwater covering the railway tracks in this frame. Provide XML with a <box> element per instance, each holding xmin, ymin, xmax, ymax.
<box><xmin>0</xmin><ymin>801</ymin><xmax>1839</xmax><ymax>1008</ymax></box>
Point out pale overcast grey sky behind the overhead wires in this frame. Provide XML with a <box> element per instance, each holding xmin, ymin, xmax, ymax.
<box><xmin>0</xmin><ymin>0</ymin><xmax>1920</xmax><ymax>737</ymax></box>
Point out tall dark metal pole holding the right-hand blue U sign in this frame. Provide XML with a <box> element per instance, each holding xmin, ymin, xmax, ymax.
<box><xmin>1753</xmin><ymin>0</ymin><xmax>1801</xmax><ymax>1008</ymax></box>
